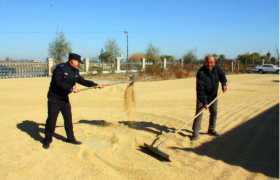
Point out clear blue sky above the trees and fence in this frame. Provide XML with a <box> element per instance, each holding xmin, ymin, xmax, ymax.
<box><xmin>0</xmin><ymin>0</ymin><xmax>279</xmax><ymax>61</ymax></box>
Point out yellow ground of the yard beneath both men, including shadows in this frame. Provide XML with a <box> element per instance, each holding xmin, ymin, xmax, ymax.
<box><xmin>0</xmin><ymin>74</ymin><xmax>279</xmax><ymax>180</ymax></box>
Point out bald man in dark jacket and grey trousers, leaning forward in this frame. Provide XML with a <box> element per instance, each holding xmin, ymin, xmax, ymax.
<box><xmin>190</xmin><ymin>56</ymin><xmax>227</xmax><ymax>141</ymax></box>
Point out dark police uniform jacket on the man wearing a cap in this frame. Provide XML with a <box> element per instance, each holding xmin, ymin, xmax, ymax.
<box><xmin>48</xmin><ymin>62</ymin><xmax>98</xmax><ymax>102</ymax></box>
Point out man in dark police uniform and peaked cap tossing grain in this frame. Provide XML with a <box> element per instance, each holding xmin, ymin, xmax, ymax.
<box><xmin>43</xmin><ymin>53</ymin><xmax>104</xmax><ymax>149</ymax></box>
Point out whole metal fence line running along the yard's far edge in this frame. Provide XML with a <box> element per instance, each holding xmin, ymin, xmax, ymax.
<box><xmin>0</xmin><ymin>61</ymin><xmax>256</xmax><ymax>79</ymax></box>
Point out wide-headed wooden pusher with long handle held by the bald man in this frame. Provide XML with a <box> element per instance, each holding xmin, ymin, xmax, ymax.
<box><xmin>144</xmin><ymin>81</ymin><xmax>230</xmax><ymax>161</ymax></box>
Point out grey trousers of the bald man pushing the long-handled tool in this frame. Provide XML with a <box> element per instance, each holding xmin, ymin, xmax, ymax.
<box><xmin>192</xmin><ymin>99</ymin><xmax>218</xmax><ymax>136</ymax></box>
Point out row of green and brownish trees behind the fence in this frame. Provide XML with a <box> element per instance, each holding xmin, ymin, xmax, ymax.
<box><xmin>48</xmin><ymin>30</ymin><xmax>278</xmax><ymax>64</ymax></box>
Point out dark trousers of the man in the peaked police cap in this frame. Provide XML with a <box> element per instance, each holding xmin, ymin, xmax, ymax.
<box><xmin>44</xmin><ymin>101</ymin><xmax>75</xmax><ymax>143</ymax></box>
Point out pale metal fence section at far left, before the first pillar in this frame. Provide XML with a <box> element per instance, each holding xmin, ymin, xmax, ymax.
<box><xmin>0</xmin><ymin>62</ymin><xmax>48</xmax><ymax>79</ymax></box>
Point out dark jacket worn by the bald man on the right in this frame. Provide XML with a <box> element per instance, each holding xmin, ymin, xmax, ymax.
<box><xmin>196</xmin><ymin>65</ymin><xmax>227</xmax><ymax>105</ymax></box>
